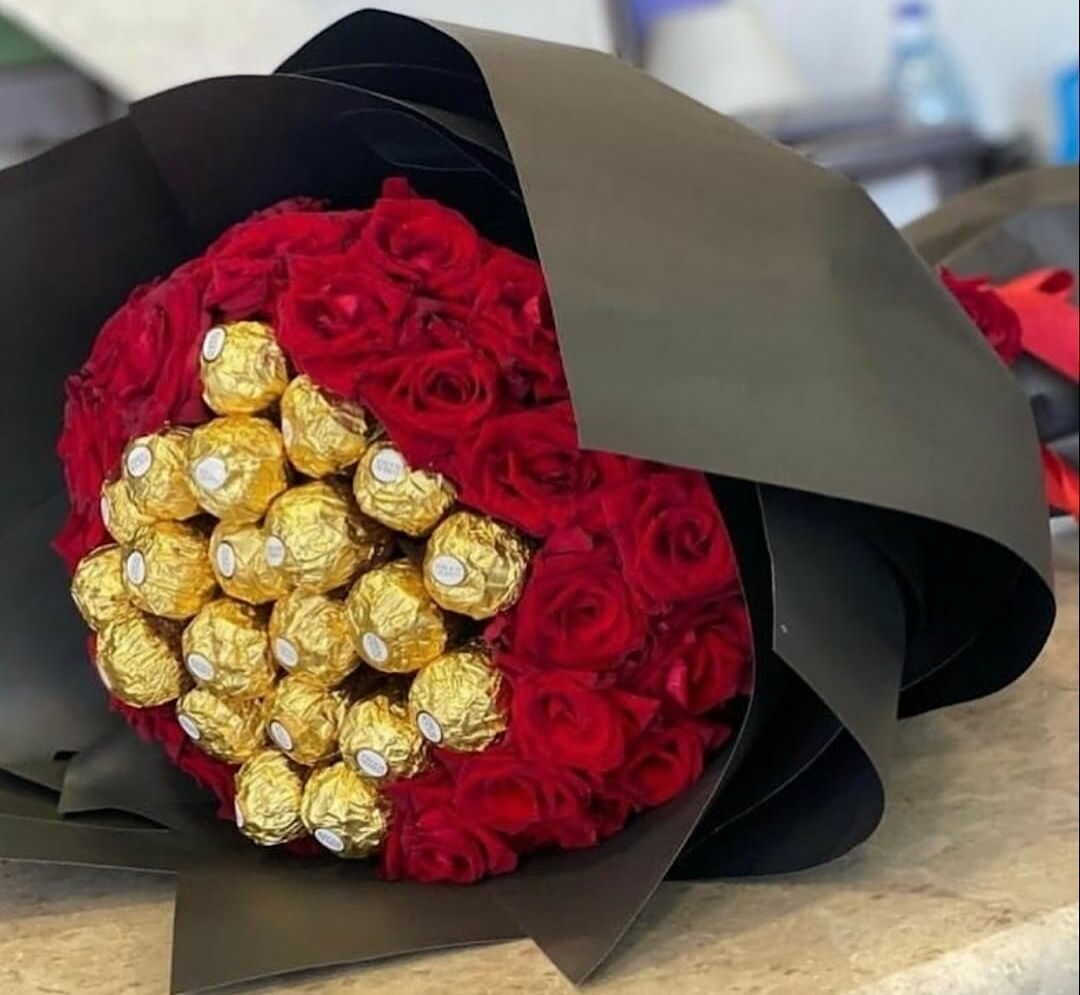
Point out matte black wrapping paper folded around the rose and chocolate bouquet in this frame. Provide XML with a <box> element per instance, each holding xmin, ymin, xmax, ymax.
<box><xmin>0</xmin><ymin>11</ymin><xmax>1053</xmax><ymax>991</ymax></box>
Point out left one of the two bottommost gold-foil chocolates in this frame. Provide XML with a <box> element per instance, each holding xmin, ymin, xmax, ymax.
<box><xmin>235</xmin><ymin>750</ymin><xmax>308</xmax><ymax>846</ymax></box>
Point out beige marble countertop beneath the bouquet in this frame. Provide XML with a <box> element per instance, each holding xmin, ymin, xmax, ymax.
<box><xmin>0</xmin><ymin>526</ymin><xmax>1078</xmax><ymax>995</ymax></box>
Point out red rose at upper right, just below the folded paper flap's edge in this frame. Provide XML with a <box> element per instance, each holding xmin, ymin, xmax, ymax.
<box><xmin>603</xmin><ymin>470</ymin><xmax>737</xmax><ymax>606</ymax></box>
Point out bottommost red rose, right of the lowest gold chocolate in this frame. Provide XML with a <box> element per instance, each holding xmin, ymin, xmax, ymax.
<box><xmin>382</xmin><ymin>806</ymin><xmax>517</xmax><ymax>885</ymax></box>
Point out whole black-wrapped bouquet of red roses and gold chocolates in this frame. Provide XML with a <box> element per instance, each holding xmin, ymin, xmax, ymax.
<box><xmin>0</xmin><ymin>11</ymin><xmax>1053</xmax><ymax>991</ymax></box>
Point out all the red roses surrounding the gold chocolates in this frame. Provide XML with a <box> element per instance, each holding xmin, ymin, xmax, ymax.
<box><xmin>55</xmin><ymin>180</ymin><xmax>751</xmax><ymax>883</ymax></box>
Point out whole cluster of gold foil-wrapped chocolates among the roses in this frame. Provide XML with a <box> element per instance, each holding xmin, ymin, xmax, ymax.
<box><xmin>71</xmin><ymin>322</ymin><xmax>529</xmax><ymax>857</ymax></box>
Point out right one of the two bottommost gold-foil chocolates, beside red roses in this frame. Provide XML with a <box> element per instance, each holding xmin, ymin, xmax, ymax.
<box><xmin>300</xmin><ymin>763</ymin><xmax>389</xmax><ymax>857</ymax></box>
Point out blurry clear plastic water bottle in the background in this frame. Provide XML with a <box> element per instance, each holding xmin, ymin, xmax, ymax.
<box><xmin>889</xmin><ymin>0</ymin><xmax>970</xmax><ymax>127</ymax></box>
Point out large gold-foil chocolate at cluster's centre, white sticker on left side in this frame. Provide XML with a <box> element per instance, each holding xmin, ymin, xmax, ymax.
<box><xmin>265</xmin><ymin>481</ymin><xmax>391</xmax><ymax>592</ymax></box>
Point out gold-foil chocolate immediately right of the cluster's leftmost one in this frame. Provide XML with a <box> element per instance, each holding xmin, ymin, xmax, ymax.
<box><xmin>122</xmin><ymin>522</ymin><xmax>216</xmax><ymax>619</ymax></box>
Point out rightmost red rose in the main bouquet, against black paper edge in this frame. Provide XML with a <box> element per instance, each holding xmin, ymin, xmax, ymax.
<box><xmin>625</xmin><ymin>594</ymin><xmax>751</xmax><ymax>715</ymax></box>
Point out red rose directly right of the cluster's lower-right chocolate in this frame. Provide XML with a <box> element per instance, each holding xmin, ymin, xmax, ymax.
<box><xmin>511</xmin><ymin>671</ymin><xmax>657</xmax><ymax>774</ymax></box>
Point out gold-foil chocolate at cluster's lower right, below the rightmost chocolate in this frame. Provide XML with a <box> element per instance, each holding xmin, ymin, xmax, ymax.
<box><xmin>408</xmin><ymin>646</ymin><xmax>507</xmax><ymax>751</ymax></box>
